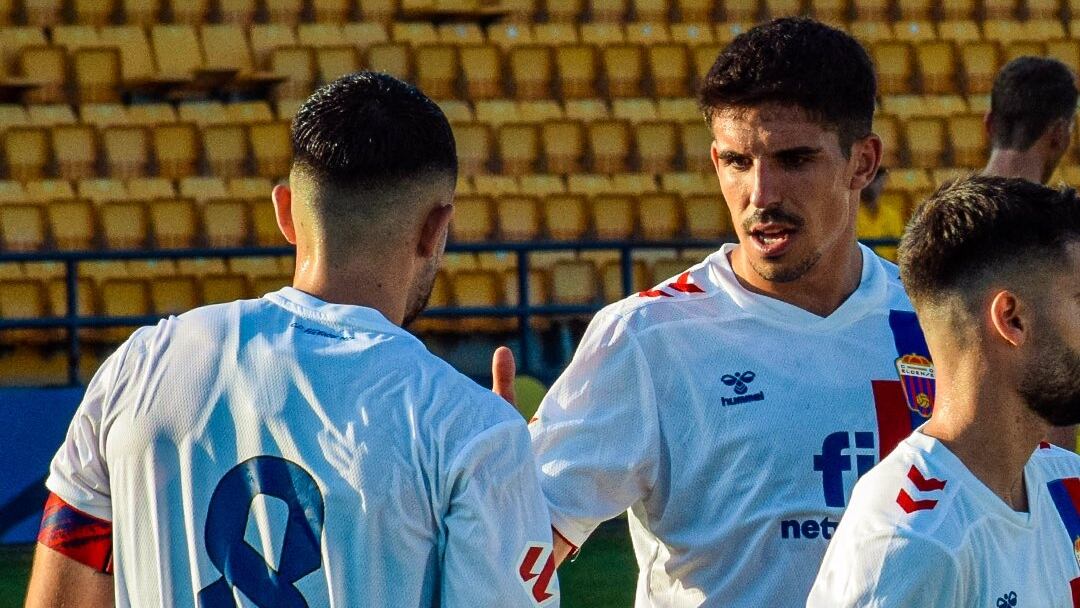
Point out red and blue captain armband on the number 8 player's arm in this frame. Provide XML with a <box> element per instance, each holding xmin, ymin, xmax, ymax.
<box><xmin>38</xmin><ymin>494</ymin><xmax>112</xmax><ymax>575</ymax></box>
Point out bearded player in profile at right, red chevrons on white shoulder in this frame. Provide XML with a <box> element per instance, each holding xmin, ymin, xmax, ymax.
<box><xmin>808</xmin><ymin>177</ymin><xmax>1080</xmax><ymax>608</ymax></box>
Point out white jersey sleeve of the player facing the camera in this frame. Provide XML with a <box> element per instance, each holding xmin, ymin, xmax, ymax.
<box><xmin>529</xmin><ymin>313</ymin><xmax>662</xmax><ymax>548</ymax></box>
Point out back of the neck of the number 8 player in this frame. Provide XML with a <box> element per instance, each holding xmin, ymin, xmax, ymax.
<box><xmin>293</xmin><ymin>251</ymin><xmax>407</xmax><ymax>325</ymax></box>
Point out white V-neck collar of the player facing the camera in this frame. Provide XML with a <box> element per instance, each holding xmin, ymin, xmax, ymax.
<box><xmin>706</xmin><ymin>243</ymin><xmax>889</xmax><ymax>332</ymax></box>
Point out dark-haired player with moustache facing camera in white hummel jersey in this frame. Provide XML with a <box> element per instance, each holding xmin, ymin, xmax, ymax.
<box><xmin>529</xmin><ymin>18</ymin><xmax>933</xmax><ymax>607</ymax></box>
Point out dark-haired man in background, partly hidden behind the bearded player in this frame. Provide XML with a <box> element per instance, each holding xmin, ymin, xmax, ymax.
<box><xmin>983</xmin><ymin>57</ymin><xmax>1078</xmax><ymax>450</ymax></box>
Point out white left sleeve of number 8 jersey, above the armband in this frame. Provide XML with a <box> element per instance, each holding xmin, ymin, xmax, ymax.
<box><xmin>45</xmin><ymin>339</ymin><xmax>140</xmax><ymax>522</ymax></box>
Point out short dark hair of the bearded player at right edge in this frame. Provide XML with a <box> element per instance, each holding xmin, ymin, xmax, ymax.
<box><xmin>900</xmin><ymin>175</ymin><xmax>1080</xmax><ymax>306</ymax></box>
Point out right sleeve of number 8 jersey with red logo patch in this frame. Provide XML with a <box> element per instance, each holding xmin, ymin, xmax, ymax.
<box><xmin>440</xmin><ymin>419</ymin><xmax>558</xmax><ymax>608</ymax></box>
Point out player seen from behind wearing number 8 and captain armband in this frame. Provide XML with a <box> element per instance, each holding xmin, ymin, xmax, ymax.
<box><xmin>28</xmin><ymin>72</ymin><xmax>558</xmax><ymax>608</ymax></box>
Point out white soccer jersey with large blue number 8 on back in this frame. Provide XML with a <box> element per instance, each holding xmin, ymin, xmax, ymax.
<box><xmin>48</xmin><ymin>287</ymin><xmax>558</xmax><ymax>608</ymax></box>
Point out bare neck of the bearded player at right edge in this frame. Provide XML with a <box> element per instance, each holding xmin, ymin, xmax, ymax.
<box><xmin>922</xmin><ymin>358</ymin><xmax>1047</xmax><ymax>511</ymax></box>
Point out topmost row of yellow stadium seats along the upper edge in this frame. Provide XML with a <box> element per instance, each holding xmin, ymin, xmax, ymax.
<box><xmin>6</xmin><ymin>0</ymin><xmax>1080</xmax><ymax>25</ymax></box>
